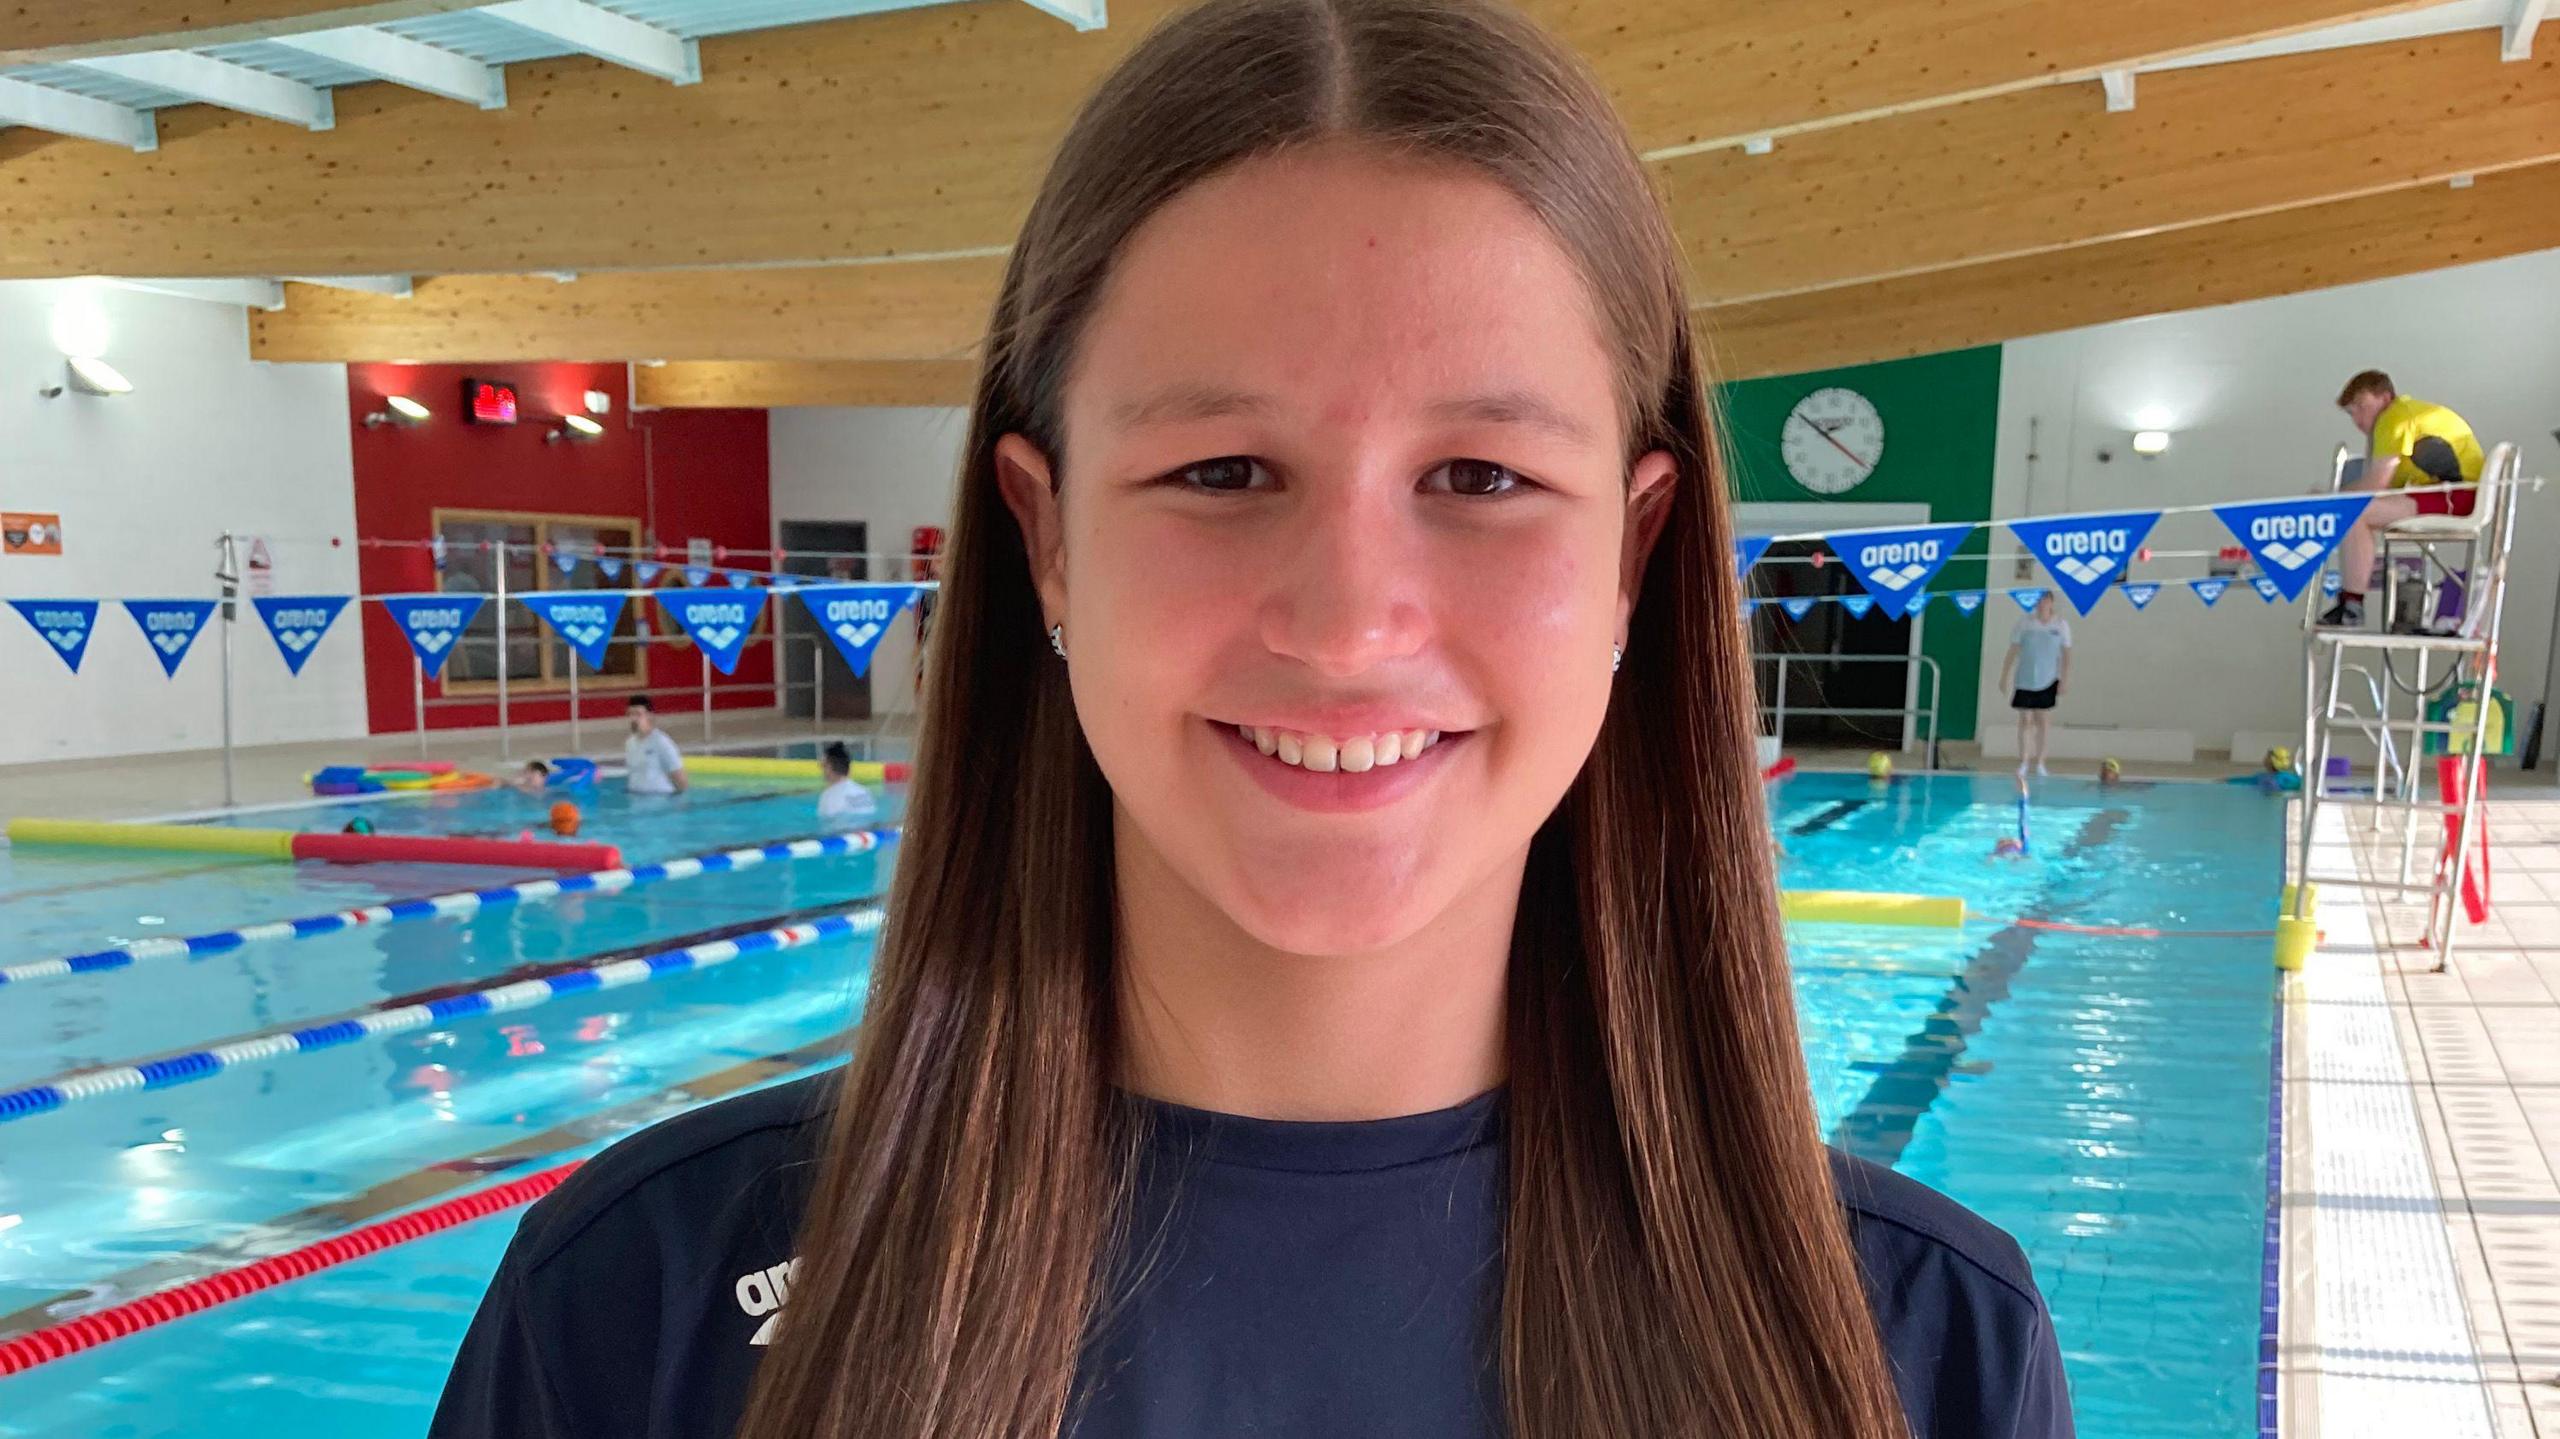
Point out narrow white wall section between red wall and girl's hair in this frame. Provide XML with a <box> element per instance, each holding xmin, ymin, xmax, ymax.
<box><xmin>768</xmin><ymin>407</ymin><xmax>968</xmax><ymax>714</ymax></box>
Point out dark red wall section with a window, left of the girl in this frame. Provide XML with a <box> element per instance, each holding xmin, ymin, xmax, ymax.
<box><xmin>348</xmin><ymin>364</ymin><xmax>773</xmax><ymax>735</ymax></box>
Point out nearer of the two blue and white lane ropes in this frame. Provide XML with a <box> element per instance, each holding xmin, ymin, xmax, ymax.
<box><xmin>0</xmin><ymin>904</ymin><xmax>881</xmax><ymax>1121</ymax></box>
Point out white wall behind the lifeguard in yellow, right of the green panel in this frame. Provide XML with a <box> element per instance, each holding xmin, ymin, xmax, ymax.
<box><xmin>1981</xmin><ymin>251</ymin><xmax>2560</xmax><ymax>753</ymax></box>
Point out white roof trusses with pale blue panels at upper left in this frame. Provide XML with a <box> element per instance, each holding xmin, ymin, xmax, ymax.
<box><xmin>0</xmin><ymin>0</ymin><xmax>1106</xmax><ymax>151</ymax></box>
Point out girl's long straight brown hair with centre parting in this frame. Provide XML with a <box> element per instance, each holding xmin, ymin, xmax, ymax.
<box><xmin>742</xmin><ymin>0</ymin><xmax>1907</xmax><ymax>1439</ymax></box>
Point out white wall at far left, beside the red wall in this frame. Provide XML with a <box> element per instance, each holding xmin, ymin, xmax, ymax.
<box><xmin>0</xmin><ymin>282</ymin><xmax>366</xmax><ymax>763</ymax></box>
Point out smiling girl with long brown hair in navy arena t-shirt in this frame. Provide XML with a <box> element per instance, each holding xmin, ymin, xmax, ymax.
<box><xmin>435</xmin><ymin>0</ymin><xmax>2071</xmax><ymax>1439</ymax></box>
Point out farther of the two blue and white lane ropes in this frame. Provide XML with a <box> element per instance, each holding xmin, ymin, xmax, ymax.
<box><xmin>0</xmin><ymin>824</ymin><xmax>901</xmax><ymax>986</ymax></box>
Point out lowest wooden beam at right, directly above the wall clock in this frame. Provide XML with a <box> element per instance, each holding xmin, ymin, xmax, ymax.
<box><xmin>1697</xmin><ymin>164</ymin><xmax>2560</xmax><ymax>379</ymax></box>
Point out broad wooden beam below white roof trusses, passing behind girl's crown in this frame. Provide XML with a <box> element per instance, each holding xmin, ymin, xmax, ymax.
<box><xmin>0</xmin><ymin>0</ymin><xmax>2467</xmax><ymax>279</ymax></box>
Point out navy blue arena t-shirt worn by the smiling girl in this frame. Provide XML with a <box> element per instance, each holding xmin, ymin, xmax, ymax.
<box><xmin>430</xmin><ymin>1073</ymin><xmax>2071</xmax><ymax>1439</ymax></box>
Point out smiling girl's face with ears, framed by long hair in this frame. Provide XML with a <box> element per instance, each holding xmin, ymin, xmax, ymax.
<box><xmin>998</xmin><ymin>146</ymin><xmax>1674</xmax><ymax>955</ymax></box>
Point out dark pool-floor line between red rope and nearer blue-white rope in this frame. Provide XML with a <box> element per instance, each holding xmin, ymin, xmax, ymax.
<box><xmin>0</xmin><ymin>1029</ymin><xmax>852</xmax><ymax>1342</ymax></box>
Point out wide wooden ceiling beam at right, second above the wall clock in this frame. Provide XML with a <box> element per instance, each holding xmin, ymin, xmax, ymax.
<box><xmin>1658</xmin><ymin>31</ymin><xmax>2560</xmax><ymax>305</ymax></box>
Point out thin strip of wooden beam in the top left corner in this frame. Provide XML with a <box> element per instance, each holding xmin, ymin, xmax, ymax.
<box><xmin>0</xmin><ymin>0</ymin><xmax>486</xmax><ymax>67</ymax></box>
